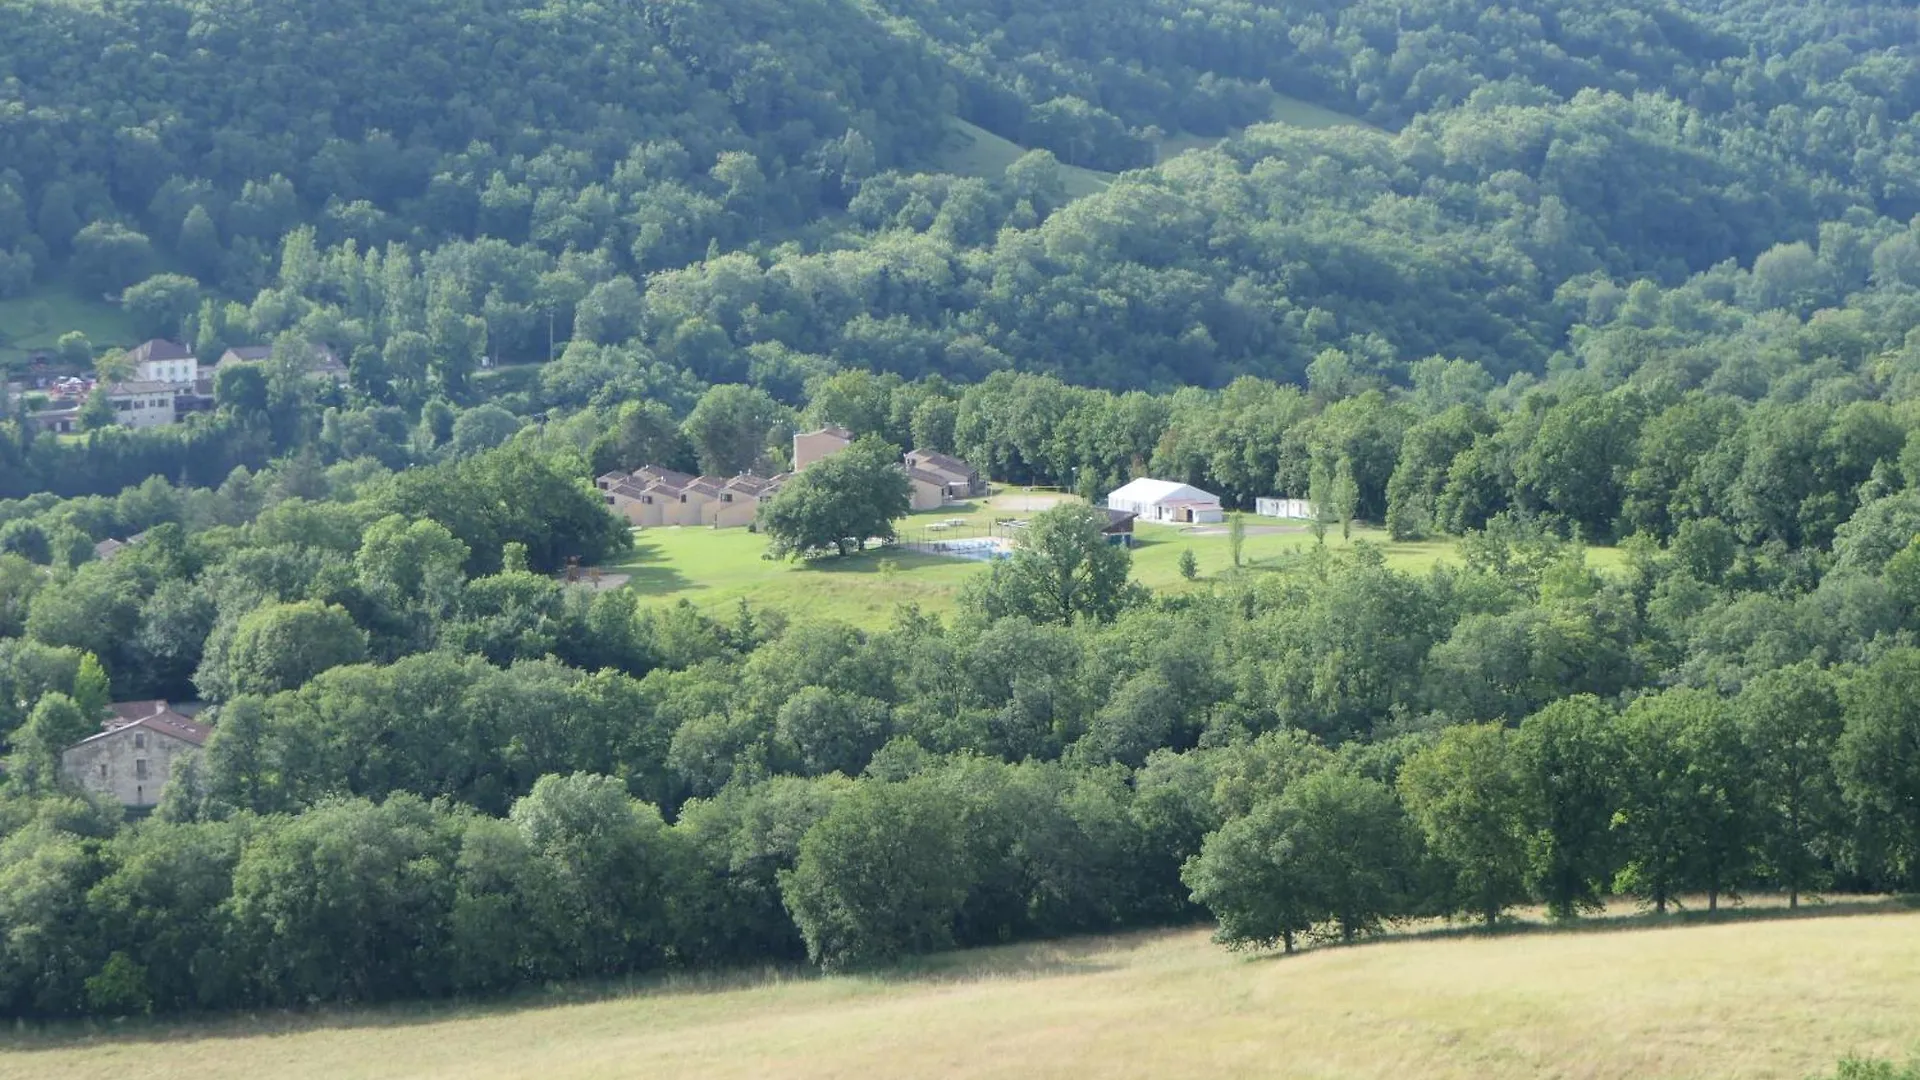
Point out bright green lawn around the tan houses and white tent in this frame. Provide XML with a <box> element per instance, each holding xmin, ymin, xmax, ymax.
<box><xmin>605</xmin><ymin>490</ymin><xmax>1622</xmax><ymax>628</ymax></box>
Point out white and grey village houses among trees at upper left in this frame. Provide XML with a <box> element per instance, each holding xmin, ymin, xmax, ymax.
<box><xmin>27</xmin><ymin>338</ymin><xmax>348</xmax><ymax>432</ymax></box>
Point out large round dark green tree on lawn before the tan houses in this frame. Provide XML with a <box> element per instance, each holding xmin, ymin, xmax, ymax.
<box><xmin>760</xmin><ymin>434</ymin><xmax>912</xmax><ymax>557</ymax></box>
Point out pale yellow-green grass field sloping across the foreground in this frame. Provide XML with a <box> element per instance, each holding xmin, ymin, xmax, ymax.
<box><xmin>0</xmin><ymin>909</ymin><xmax>1920</xmax><ymax>1080</ymax></box>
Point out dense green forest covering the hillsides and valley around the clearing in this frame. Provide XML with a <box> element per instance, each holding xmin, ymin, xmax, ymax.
<box><xmin>0</xmin><ymin>0</ymin><xmax>1920</xmax><ymax>1017</ymax></box>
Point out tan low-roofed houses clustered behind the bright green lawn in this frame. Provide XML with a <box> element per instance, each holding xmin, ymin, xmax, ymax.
<box><xmin>595</xmin><ymin>427</ymin><xmax>987</xmax><ymax>528</ymax></box>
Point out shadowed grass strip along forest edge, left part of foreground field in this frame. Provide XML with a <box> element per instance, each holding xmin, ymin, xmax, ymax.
<box><xmin>0</xmin><ymin>930</ymin><xmax>1177</xmax><ymax>1055</ymax></box>
